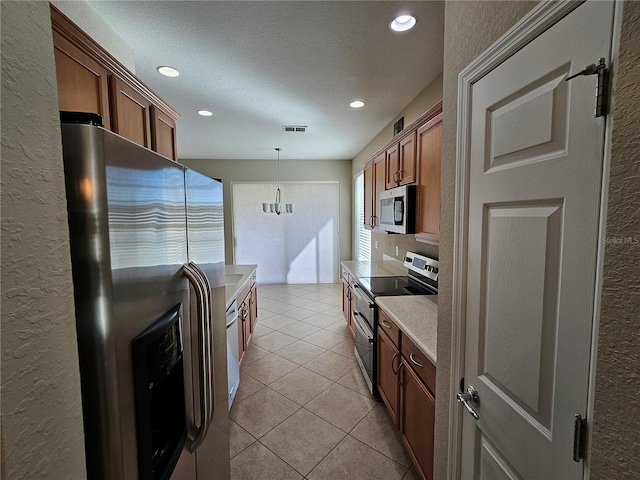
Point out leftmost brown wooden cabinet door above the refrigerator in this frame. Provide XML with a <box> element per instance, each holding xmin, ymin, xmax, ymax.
<box><xmin>53</xmin><ymin>31</ymin><xmax>111</xmax><ymax>129</ymax></box>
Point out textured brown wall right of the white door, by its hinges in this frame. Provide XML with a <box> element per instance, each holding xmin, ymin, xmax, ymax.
<box><xmin>590</xmin><ymin>2</ymin><xmax>640</xmax><ymax>479</ymax></box>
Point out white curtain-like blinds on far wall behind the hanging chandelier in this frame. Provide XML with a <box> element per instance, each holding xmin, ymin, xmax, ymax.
<box><xmin>231</xmin><ymin>182</ymin><xmax>339</xmax><ymax>284</ymax></box>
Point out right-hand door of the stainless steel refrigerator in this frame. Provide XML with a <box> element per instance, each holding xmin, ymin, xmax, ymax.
<box><xmin>183</xmin><ymin>169</ymin><xmax>230</xmax><ymax>480</ymax></box>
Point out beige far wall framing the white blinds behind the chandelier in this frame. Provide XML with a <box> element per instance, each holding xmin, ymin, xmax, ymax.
<box><xmin>180</xmin><ymin>158</ymin><xmax>353</xmax><ymax>270</ymax></box>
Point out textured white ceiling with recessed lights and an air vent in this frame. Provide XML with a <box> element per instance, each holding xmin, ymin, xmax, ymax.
<box><xmin>88</xmin><ymin>1</ymin><xmax>444</xmax><ymax>160</ymax></box>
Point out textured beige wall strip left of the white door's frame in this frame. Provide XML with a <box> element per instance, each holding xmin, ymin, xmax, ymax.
<box><xmin>434</xmin><ymin>1</ymin><xmax>537</xmax><ymax>480</ymax></box>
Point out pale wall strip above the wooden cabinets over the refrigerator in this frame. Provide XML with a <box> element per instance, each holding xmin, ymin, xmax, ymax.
<box><xmin>51</xmin><ymin>0</ymin><xmax>136</xmax><ymax>73</ymax></box>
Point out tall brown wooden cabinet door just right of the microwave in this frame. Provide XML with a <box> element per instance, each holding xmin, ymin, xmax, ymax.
<box><xmin>416</xmin><ymin>113</ymin><xmax>442</xmax><ymax>243</ymax></box>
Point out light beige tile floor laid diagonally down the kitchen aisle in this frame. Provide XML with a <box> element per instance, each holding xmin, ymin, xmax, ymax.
<box><xmin>230</xmin><ymin>284</ymin><xmax>418</xmax><ymax>480</ymax></box>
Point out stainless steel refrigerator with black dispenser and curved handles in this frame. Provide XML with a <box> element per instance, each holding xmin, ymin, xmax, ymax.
<box><xmin>61</xmin><ymin>115</ymin><xmax>229</xmax><ymax>480</ymax></box>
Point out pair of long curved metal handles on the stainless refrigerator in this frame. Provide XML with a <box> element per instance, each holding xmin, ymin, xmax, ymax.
<box><xmin>182</xmin><ymin>264</ymin><xmax>210</xmax><ymax>452</ymax></box>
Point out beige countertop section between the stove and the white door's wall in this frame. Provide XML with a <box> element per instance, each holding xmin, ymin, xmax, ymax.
<box><xmin>376</xmin><ymin>295</ymin><xmax>438</xmax><ymax>367</ymax></box>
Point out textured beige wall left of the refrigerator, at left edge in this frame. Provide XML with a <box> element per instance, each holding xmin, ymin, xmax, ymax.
<box><xmin>1</xmin><ymin>1</ymin><xmax>86</xmax><ymax>480</ymax></box>
